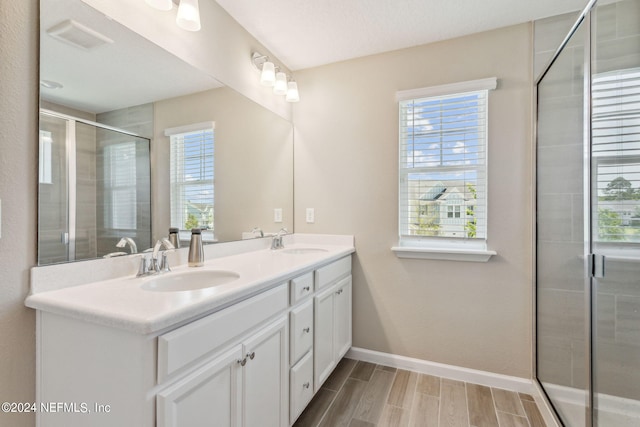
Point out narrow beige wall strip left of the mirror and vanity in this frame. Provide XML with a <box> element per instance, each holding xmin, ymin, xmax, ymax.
<box><xmin>0</xmin><ymin>0</ymin><xmax>38</xmax><ymax>427</ymax></box>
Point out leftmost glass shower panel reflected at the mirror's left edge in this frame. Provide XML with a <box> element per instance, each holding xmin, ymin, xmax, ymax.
<box><xmin>38</xmin><ymin>113</ymin><xmax>75</xmax><ymax>264</ymax></box>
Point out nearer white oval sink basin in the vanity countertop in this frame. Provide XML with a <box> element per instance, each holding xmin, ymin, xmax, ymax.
<box><xmin>142</xmin><ymin>270</ymin><xmax>240</xmax><ymax>292</ymax></box>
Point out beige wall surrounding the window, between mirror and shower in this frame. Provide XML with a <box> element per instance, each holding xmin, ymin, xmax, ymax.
<box><xmin>294</xmin><ymin>24</ymin><xmax>532</xmax><ymax>378</ymax></box>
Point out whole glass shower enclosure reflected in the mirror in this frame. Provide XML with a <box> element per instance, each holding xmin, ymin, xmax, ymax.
<box><xmin>38</xmin><ymin>110</ymin><xmax>151</xmax><ymax>265</ymax></box>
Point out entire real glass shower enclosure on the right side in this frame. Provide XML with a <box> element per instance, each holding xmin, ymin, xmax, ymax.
<box><xmin>536</xmin><ymin>0</ymin><xmax>640</xmax><ymax>427</ymax></box>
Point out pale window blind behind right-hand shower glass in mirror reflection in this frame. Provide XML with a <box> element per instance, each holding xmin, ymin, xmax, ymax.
<box><xmin>104</xmin><ymin>141</ymin><xmax>137</xmax><ymax>230</ymax></box>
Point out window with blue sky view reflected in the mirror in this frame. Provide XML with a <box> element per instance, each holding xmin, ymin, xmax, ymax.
<box><xmin>165</xmin><ymin>122</ymin><xmax>214</xmax><ymax>230</ymax></box>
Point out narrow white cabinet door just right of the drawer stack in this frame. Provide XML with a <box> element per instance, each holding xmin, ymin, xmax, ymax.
<box><xmin>313</xmin><ymin>286</ymin><xmax>336</xmax><ymax>392</ymax></box>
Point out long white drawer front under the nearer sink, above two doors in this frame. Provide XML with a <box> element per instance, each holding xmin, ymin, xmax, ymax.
<box><xmin>158</xmin><ymin>283</ymin><xmax>289</xmax><ymax>383</ymax></box>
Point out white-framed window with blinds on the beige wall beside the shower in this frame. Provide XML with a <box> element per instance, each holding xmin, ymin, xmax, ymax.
<box><xmin>394</xmin><ymin>78</ymin><xmax>497</xmax><ymax>262</ymax></box>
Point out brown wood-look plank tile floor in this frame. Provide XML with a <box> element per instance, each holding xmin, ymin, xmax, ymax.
<box><xmin>294</xmin><ymin>358</ymin><xmax>545</xmax><ymax>427</ymax></box>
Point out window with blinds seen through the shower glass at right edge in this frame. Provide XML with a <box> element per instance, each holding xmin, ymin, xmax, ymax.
<box><xmin>592</xmin><ymin>68</ymin><xmax>640</xmax><ymax>244</ymax></box>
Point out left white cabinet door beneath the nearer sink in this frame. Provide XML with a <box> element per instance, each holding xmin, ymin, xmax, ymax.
<box><xmin>157</xmin><ymin>345</ymin><xmax>242</xmax><ymax>427</ymax></box>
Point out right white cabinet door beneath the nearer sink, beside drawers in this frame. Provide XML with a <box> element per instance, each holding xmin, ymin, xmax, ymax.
<box><xmin>242</xmin><ymin>317</ymin><xmax>289</xmax><ymax>427</ymax></box>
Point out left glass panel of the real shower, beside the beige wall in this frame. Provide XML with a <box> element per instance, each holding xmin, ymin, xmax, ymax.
<box><xmin>536</xmin><ymin>18</ymin><xmax>589</xmax><ymax>426</ymax></box>
